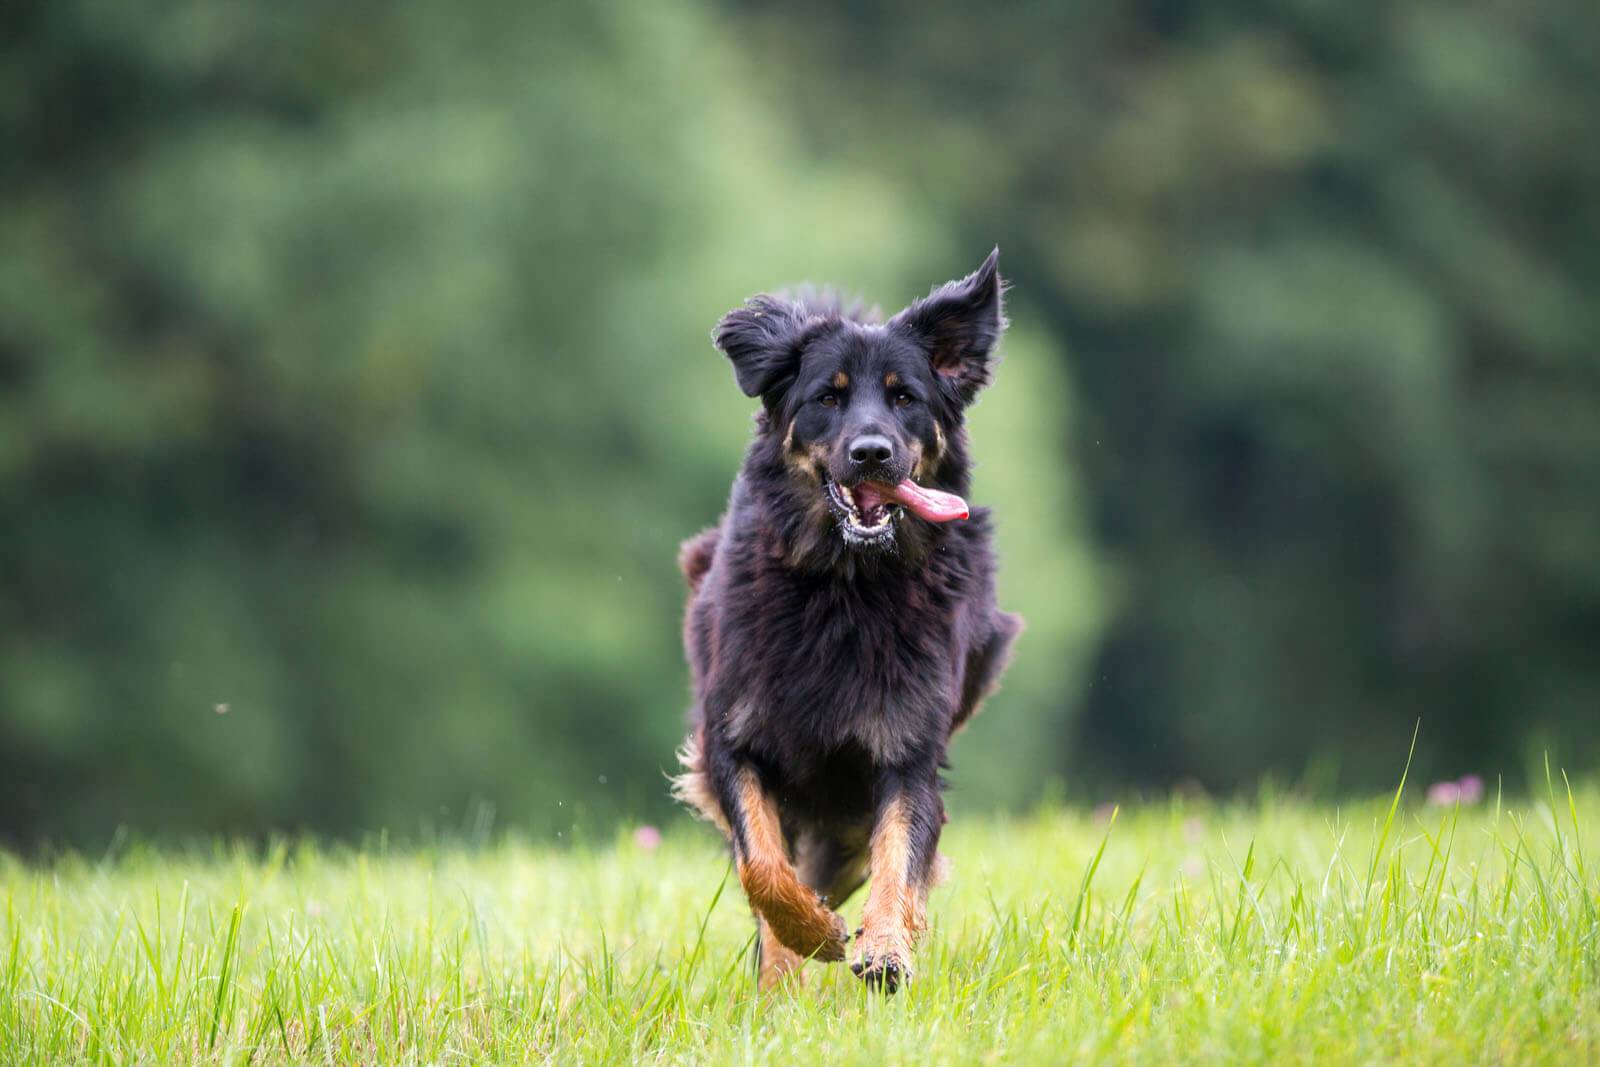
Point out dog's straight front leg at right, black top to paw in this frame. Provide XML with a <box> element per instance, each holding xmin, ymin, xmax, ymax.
<box><xmin>850</xmin><ymin>773</ymin><xmax>944</xmax><ymax>992</ymax></box>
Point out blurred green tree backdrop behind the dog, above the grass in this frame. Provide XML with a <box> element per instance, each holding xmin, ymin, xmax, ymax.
<box><xmin>0</xmin><ymin>0</ymin><xmax>1600</xmax><ymax>843</ymax></box>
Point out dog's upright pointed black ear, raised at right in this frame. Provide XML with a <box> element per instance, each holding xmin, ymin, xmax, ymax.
<box><xmin>890</xmin><ymin>248</ymin><xmax>1005</xmax><ymax>403</ymax></box>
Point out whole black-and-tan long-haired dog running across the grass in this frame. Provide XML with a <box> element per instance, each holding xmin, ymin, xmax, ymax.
<box><xmin>674</xmin><ymin>248</ymin><xmax>1021</xmax><ymax>992</ymax></box>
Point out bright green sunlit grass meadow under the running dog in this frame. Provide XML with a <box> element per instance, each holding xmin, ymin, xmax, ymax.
<box><xmin>0</xmin><ymin>782</ymin><xmax>1600</xmax><ymax>1064</ymax></box>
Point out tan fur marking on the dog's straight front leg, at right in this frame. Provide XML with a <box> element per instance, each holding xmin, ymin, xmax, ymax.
<box><xmin>851</xmin><ymin>797</ymin><xmax>926</xmax><ymax>990</ymax></box>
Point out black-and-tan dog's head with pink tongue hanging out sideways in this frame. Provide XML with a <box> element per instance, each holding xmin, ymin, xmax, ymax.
<box><xmin>712</xmin><ymin>250</ymin><xmax>1005</xmax><ymax>550</ymax></box>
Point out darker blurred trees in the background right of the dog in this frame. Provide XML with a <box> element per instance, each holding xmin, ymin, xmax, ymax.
<box><xmin>739</xmin><ymin>0</ymin><xmax>1600</xmax><ymax>787</ymax></box>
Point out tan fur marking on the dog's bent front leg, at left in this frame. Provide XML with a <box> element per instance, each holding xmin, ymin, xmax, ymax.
<box><xmin>739</xmin><ymin>771</ymin><xmax>845</xmax><ymax>960</ymax></box>
